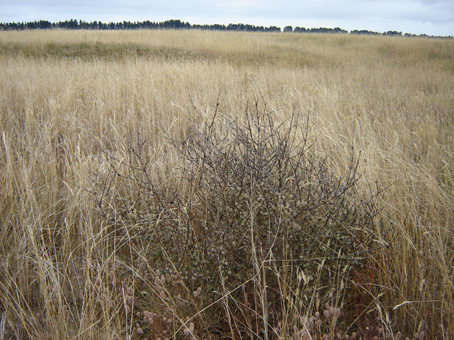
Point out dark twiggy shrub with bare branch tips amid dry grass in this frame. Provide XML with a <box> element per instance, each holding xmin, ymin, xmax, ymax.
<box><xmin>91</xmin><ymin>103</ymin><xmax>376</xmax><ymax>337</ymax></box>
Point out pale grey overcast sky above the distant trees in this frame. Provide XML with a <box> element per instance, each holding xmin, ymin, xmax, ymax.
<box><xmin>0</xmin><ymin>0</ymin><xmax>454</xmax><ymax>36</ymax></box>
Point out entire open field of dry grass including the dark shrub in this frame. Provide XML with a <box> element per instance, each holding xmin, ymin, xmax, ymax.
<box><xmin>0</xmin><ymin>30</ymin><xmax>454</xmax><ymax>339</ymax></box>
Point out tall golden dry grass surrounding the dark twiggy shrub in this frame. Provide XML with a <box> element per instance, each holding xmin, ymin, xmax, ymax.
<box><xmin>0</xmin><ymin>30</ymin><xmax>454</xmax><ymax>339</ymax></box>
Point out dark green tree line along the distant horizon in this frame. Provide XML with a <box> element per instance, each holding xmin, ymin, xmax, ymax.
<box><xmin>0</xmin><ymin>19</ymin><xmax>453</xmax><ymax>38</ymax></box>
